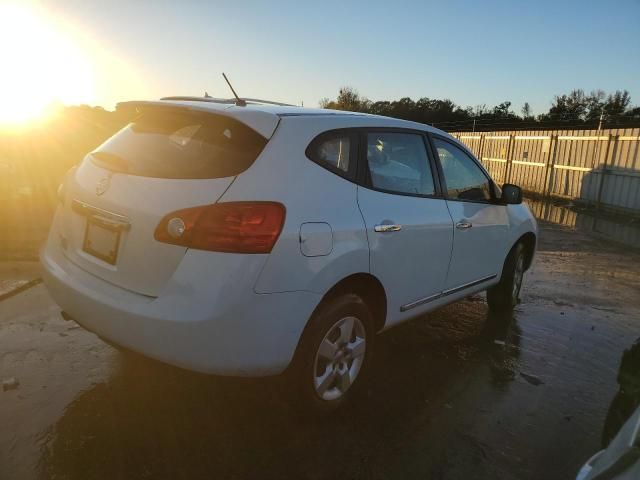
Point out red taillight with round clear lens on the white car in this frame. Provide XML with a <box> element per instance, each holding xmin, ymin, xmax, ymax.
<box><xmin>154</xmin><ymin>202</ymin><xmax>285</xmax><ymax>253</ymax></box>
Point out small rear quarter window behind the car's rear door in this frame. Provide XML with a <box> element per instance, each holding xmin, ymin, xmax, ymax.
<box><xmin>306</xmin><ymin>130</ymin><xmax>357</xmax><ymax>176</ymax></box>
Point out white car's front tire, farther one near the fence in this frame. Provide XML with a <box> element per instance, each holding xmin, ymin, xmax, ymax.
<box><xmin>487</xmin><ymin>243</ymin><xmax>525</xmax><ymax>312</ymax></box>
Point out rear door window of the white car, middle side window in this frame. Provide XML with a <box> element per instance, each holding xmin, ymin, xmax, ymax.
<box><xmin>367</xmin><ymin>132</ymin><xmax>435</xmax><ymax>195</ymax></box>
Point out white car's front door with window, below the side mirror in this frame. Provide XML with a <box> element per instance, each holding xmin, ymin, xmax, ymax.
<box><xmin>431</xmin><ymin>135</ymin><xmax>509</xmax><ymax>293</ymax></box>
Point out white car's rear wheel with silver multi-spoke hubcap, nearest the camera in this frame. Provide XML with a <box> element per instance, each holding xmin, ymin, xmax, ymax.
<box><xmin>290</xmin><ymin>293</ymin><xmax>375</xmax><ymax>413</ymax></box>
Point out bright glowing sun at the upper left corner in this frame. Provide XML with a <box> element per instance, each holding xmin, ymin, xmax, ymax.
<box><xmin>0</xmin><ymin>0</ymin><xmax>94</xmax><ymax>127</ymax></box>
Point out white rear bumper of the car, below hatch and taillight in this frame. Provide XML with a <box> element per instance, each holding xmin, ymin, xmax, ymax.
<box><xmin>40</xmin><ymin>239</ymin><xmax>320</xmax><ymax>376</ymax></box>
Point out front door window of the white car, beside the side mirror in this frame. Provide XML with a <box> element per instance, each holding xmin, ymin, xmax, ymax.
<box><xmin>433</xmin><ymin>138</ymin><xmax>491</xmax><ymax>201</ymax></box>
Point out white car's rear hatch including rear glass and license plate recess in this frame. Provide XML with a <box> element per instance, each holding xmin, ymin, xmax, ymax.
<box><xmin>55</xmin><ymin>105</ymin><xmax>275</xmax><ymax>296</ymax></box>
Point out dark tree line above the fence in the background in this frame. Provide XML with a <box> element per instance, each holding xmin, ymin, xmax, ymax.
<box><xmin>320</xmin><ymin>87</ymin><xmax>640</xmax><ymax>131</ymax></box>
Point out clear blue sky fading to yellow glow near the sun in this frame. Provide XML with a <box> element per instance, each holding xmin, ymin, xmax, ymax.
<box><xmin>0</xmin><ymin>0</ymin><xmax>640</xmax><ymax>119</ymax></box>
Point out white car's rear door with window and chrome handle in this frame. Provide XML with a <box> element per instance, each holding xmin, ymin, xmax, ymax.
<box><xmin>358</xmin><ymin>130</ymin><xmax>453</xmax><ymax>325</ymax></box>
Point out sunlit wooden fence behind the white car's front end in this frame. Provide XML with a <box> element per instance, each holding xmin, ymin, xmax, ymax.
<box><xmin>451</xmin><ymin>128</ymin><xmax>640</xmax><ymax>214</ymax></box>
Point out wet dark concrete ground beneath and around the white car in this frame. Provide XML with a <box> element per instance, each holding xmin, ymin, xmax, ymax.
<box><xmin>0</xmin><ymin>219</ymin><xmax>640</xmax><ymax>479</ymax></box>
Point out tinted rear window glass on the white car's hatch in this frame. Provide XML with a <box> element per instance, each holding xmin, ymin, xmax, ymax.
<box><xmin>91</xmin><ymin>111</ymin><xmax>267</xmax><ymax>178</ymax></box>
